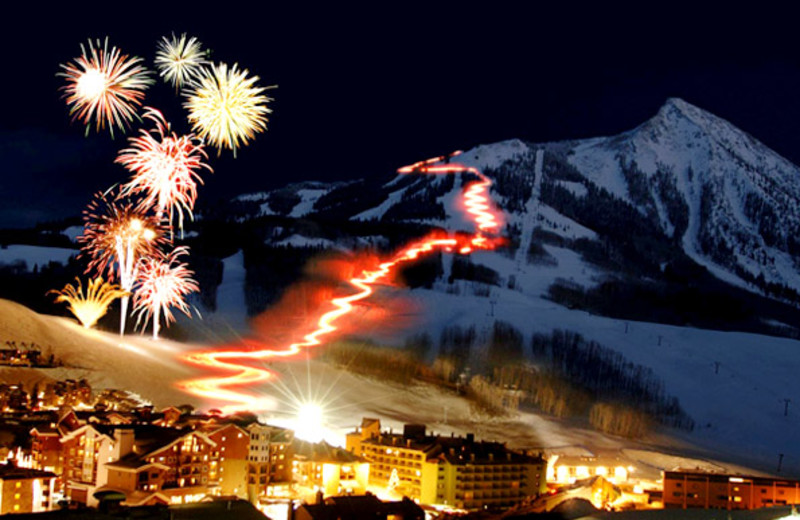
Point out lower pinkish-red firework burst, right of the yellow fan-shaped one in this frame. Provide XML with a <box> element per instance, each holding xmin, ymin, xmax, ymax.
<box><xmin>133</xmin><ymin>247</ymin><xmax>200</xmax><ymax>339</ymax></box>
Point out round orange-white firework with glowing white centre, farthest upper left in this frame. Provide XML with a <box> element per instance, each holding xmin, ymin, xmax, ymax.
<box><xmin>58</xmin><ymin>38</ymin><xmax>153</xmax><ymax>136</ymax></box>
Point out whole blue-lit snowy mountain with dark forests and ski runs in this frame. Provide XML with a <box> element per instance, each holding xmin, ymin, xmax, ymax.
<box><xmin>7</xmin><ymin>99</ymin><xmax>800</xmax><ymax>474</ymax></box>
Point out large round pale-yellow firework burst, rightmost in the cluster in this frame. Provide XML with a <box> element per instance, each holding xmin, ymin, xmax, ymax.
<box><xmin>184</xmin><ymin>63</ymin><xmax>272</xmax><ymax>157</ymax></box>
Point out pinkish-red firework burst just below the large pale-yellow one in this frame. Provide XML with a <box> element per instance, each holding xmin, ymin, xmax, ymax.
<box><xmin>116</xmin><ymin>108</ymin><xmax>211</xmax><ymax>232</ymax></box>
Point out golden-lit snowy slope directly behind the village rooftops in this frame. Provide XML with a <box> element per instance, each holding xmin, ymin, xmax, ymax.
<box><xmin>0</xmin><ymin>296</ymin><xmax>768</xmax><ymax>478</ymax></box>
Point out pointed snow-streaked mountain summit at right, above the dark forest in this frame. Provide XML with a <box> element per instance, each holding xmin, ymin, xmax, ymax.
<box><xmin>567</xmin><ymin>99</ymin><xmax>800</xmax><ymax>290</ymax></box>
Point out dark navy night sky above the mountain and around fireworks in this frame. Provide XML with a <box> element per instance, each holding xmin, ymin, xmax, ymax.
<box><xmin>0</xmin><ymin>1</ymin><xmax>800</xmax><ymax>227</ymax></box>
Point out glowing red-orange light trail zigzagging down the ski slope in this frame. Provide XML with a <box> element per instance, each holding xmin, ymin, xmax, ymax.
<box><xmin>178</xmin><ymin>152</ymin><xmax>504</xmax><ymax>413</ymax></box>
